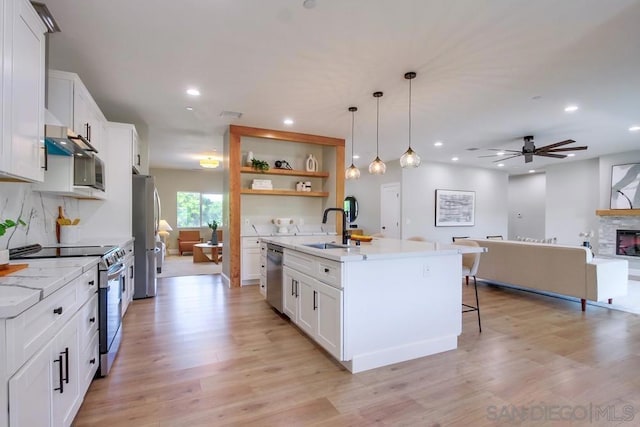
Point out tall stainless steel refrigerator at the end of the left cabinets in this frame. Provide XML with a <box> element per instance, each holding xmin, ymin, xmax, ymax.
<box><xmin>132</xmin><ymin>175</ymin><xmax>160</xmax><ymax>299</ymax></box>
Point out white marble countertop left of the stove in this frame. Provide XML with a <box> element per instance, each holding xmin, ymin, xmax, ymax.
<box><xmin>0</xmin><ymin>257</ymin><xmax>100</xmax><ymax>318</ymax></box>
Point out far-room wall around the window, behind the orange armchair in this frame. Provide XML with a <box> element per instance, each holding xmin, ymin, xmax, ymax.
<box><xmin>149</xmin><ymin>168</ymin><xmax>223</xmax><ymax>250</ymax></box>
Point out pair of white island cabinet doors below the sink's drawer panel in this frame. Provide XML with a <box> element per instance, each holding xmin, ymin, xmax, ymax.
<box><xmin>282</xmin><ymin>266</ymin><xmax>343</xmax><ymax>360</ymax></box>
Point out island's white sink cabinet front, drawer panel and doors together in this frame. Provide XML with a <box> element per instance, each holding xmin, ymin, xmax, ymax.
<box><xmin>282</xmin><ymin>249</ymin><xmax>343</xmax><ymax>360</ymax></box>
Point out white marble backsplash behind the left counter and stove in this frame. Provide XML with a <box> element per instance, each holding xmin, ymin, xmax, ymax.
<box><xmin>0</xmin><ymin>182</ymin><xmax>82</xmax><ymax>249</ymax></box>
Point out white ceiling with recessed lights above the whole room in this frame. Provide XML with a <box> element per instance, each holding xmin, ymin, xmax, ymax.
<box><xmin>44</xmin><ymin>0</ymin><xmax>640</xmax><ymax>173</ymax></box>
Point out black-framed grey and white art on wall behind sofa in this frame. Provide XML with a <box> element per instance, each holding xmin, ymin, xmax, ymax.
<box><xmin>436</xmin><ymin>190</ymin><xmax>476</xmax><ymax>227</ymax></box>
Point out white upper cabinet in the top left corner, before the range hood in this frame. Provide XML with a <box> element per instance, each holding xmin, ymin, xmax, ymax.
<box><xmin>0</xmin><ymin>0</ymin><xmax>46</xmax><ymax>182</ymax></box>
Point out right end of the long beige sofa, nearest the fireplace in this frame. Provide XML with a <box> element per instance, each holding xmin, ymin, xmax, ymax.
<box><xmin>587</xmin><ymin>258</ymin><xmax>629</xmax><ymax>301</ymax></box>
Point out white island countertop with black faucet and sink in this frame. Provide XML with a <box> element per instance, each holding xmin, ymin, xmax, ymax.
<box><xmin>262</xmin><ymin>236</ymin><xmax>486</xmax><ymax>262</ymax></box>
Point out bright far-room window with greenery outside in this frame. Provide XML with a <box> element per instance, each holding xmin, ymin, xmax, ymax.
<box><xmin>177</xmin><ymin>191</ymin><xmax>222</xmax><ymax>228</ymax></box>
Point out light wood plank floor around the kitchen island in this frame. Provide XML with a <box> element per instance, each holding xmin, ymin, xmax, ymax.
<box><xmin>74</xmin><ymin>275</ymin><xmax>640</xmax><ymax>427</ymax></box>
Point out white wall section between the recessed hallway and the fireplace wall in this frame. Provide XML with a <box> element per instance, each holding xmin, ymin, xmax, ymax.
<box><xmin>545</xmin><ymin>159</ymin><xmax>600</xmax><ymax>245</ymax></box>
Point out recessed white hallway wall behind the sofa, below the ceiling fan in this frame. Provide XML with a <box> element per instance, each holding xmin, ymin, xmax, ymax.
<box><xmin>505</xmin><ymin>173</ymin><xmax>553</xmax><ymax>240</ymax></box>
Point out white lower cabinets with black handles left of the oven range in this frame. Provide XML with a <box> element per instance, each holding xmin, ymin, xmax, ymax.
<box><xmin>0</xmin><ymin>266</ymin><xmax>99</xmax><ymax>427</ymax></box>
